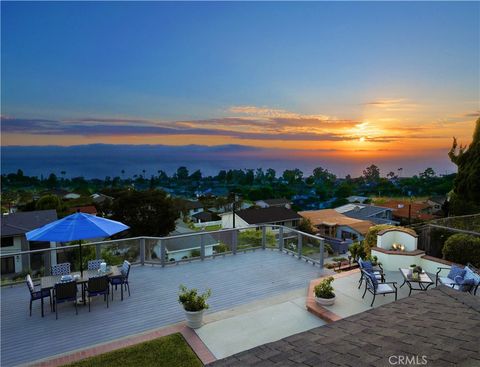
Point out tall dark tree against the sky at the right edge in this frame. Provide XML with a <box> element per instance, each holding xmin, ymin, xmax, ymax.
<box><xmin>448</xmin><ymin>118</ymin><xmax>480</xmax><ymax>215</ymax></box>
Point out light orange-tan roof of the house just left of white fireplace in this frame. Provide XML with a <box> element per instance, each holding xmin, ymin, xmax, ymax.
<box><xmin>298</xmin><ymin>209</ymin><xmax>374</xmax><ymax>235</ymax></box>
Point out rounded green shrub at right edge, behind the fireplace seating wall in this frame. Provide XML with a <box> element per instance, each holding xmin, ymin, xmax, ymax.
<box><xmin>442</xmin><ymin>233</ymin><xmax>480</xmax><ymax>267</ymax></box>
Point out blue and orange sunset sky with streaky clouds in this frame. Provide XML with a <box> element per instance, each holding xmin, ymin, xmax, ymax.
<box><xmin>1</xmin><ymin>2</ymin><xmax>480</xmax><ymax>177</ymax></box>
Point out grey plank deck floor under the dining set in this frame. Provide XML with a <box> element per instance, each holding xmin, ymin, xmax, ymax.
<box><xmin>1</xmin><ymin>250</ymin><xmax>322</xmax><ymax>366</ymax></box>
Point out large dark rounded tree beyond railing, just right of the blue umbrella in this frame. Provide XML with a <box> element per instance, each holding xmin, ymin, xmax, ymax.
<box><xmin>111</xmin><ymin>190</ymin><xmax>179</xmax><ymax>236</ymax></box>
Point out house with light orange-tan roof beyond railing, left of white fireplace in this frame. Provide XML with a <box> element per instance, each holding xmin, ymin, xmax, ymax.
<box><xmin>298</xmin><ymin>209</ymin><xmax>374</xmax><ymax>241</ymax></box>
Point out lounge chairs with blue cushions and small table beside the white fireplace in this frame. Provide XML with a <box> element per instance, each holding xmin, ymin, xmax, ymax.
<box><xmin>358</xmin><ymin>259</ymin><xmax>480</xmax><ymax>307</ymax></box>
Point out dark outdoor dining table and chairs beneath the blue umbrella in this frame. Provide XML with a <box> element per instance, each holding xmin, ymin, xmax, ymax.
<box><xmin>25</xmin><ymin>260</ymin><xmax>131</xmax><ymax>319</ymax></box>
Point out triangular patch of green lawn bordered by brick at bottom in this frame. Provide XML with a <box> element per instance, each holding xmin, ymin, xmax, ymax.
<box><xmin>64</xmin><ymin>333</ymin><xmax>203</xmax><ymax>367</ymax></box>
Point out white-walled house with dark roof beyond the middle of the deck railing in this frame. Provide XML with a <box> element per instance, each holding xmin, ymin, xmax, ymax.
<box><xmin>221</xmin><ymin>206</ymin><xmax>302</xmax><ymax>228</ymax></box>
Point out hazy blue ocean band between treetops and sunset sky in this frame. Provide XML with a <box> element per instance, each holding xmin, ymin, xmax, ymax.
<box><xmin>1</xmin><ymin>144</ymin><xmax>455</xmax><ymax>179</ymax></box>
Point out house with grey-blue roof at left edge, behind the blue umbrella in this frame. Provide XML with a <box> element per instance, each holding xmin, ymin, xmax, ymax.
<box><xmin>0</xmin><ymin>210</ymin><xmax>57</xmax><ymax>274</ymax></box>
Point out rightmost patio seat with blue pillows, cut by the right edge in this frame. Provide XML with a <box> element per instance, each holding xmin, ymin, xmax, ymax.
<box><xmin>435</xmin><ymin>263</ymin><xmax>480</xmax><ymax>295</ymax></box>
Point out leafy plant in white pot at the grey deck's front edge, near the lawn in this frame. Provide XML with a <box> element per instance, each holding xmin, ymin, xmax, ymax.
<box><xmin>178</xmin><ymin>284</ymin><xmax>212</xmax><ymax>329</ymax></box>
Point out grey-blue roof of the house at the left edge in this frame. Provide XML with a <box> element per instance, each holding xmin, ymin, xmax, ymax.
<box><xmin>1</xmin><ymin>209</ymin><xmax>58</xmax><ymax>237</ymax></box>
